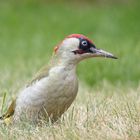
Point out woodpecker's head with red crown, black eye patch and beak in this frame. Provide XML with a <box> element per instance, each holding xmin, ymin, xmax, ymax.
<box><xmin>54</xmin><ymin>34</ymin><xmax>117</xmax><ymax>63</ymax></box>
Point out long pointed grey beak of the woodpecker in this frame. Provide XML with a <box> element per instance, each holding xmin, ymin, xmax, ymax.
<box><xmin>90</xmin><ymin>47</ymin><xmax>118</xmax><ymax>59</ymax></box>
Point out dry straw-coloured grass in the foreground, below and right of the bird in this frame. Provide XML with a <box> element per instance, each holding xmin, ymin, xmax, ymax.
<box><xmin>0</xmin><ymin>82</ymin><xmax>140</xmax><ymax>140</ymax></box>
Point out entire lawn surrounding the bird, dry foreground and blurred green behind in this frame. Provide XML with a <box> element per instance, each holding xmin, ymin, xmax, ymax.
<box><xmin>0</xmin><ymin>1</ymin><xmax>140</xmax><ymax>140</ymax></box>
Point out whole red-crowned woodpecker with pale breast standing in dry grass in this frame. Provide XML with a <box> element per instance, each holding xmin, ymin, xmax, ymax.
<box><xmin>0</xmin><ymin>34</ymin><xmax>117</xmax><ymax>123</ymax></box>
